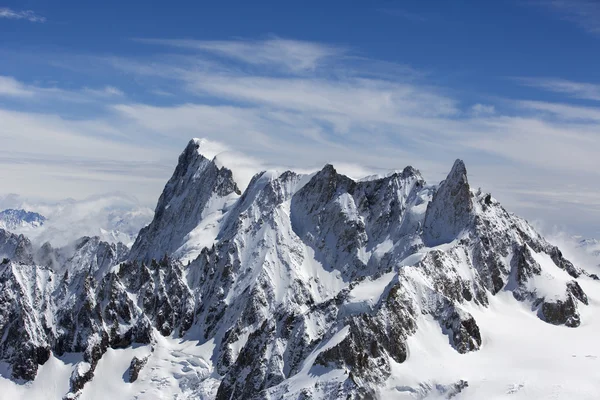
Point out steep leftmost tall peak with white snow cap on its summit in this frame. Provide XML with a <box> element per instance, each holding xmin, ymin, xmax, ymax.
<box><xmin>131</xmin><ymin>139</ymin><xmax>241</xmax><ymax>261</ymax></box>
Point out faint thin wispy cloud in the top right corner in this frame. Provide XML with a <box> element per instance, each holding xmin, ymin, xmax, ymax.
<box><xmin>538</xmin><ymin>0</ymin><xmax>600</xmax><ymax>35</ymax></box>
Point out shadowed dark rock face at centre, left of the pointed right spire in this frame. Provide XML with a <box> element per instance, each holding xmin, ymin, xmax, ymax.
<box><xmin>291</xmin><ymin>165</ymin><xmax>425</xmax><ymax>279</ymax></box>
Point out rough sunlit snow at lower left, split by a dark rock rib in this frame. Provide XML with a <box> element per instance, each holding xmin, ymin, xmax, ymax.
<box><xmin>0</xmin><ymin>332</ymin><xmax>219</xmax><ymax>400</ymax></box>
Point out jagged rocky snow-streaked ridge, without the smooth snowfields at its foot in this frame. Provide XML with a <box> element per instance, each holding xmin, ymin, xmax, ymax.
<box><xmin>0</xmin><ymin>140</ymin><xmax>598</xmax><ymax>399</ymax></box>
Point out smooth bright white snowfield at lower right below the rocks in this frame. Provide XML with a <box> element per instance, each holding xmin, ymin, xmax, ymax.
<box><xmin>382</xmin><ymin>279</ymin><xmax>600</xmax><ymax>400</ymax></box>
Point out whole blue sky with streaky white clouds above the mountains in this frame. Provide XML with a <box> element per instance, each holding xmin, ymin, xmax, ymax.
<box><xmin>0</xmin><ymin>0</ymin><xmax>600</xmax><ymax>236</ymax></box>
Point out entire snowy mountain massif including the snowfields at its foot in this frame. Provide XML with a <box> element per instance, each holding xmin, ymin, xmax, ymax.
<box><xmin>0</xmin><ymin>139</ymin><xmax>600</xmax><ymax>399</ymax></box>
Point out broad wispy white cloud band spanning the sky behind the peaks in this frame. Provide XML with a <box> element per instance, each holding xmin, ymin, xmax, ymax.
<box><xmin>0</xmin><ymin>39</ymin><xmax>600</xmax><ymax>236</ymax></box>
